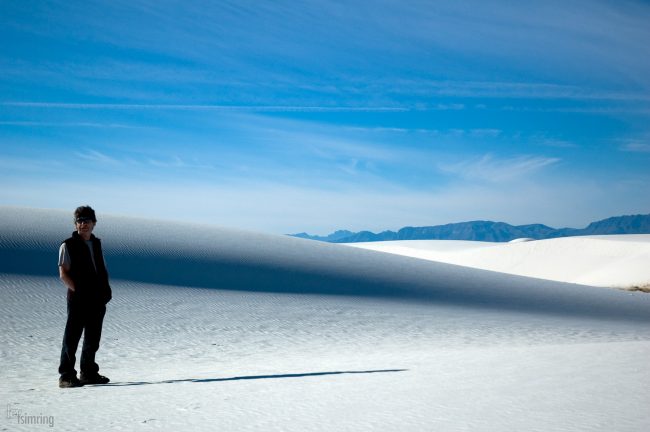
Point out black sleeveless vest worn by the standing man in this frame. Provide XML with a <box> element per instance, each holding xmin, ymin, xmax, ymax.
<box><xmin>64</xmin><ymin>232</ymin><xmax>112</xmax><ymax>304</ymax></box>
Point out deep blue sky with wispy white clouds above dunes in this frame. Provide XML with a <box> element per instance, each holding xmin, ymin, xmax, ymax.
<box><xmin>0</xmin><ymin>0</ymin><xmax>650</xmax><ymax>234</ymax></box>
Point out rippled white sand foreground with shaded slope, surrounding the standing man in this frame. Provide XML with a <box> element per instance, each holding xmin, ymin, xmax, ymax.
<box><xmin>0</xmin><ymin>208</ymin><xmax>650</xmax><ymax>431</ymax></box>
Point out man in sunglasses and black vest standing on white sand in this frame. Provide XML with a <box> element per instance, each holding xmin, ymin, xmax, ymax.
<box><xmin>59</xmin><ymin>206</ymin><xmax>112</xmax><ymax>388</ymax></box>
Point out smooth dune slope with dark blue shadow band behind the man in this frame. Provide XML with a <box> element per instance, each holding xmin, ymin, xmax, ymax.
<box><xmin>0</xmin><ymin>207</ymin><xmax>650</xmax><ymax>322</ymax></box>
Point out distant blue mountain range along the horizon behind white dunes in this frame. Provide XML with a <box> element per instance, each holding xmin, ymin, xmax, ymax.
<box><xmin>290</xmin><ymin>214</ymin><xmax>650</xmax><ymax>243</ymax></box>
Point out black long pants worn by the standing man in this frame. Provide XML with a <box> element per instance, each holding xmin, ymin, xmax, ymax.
<box><xmin>59</xmin><ymin>299</ymin><xmax>106</xmax><ymax>376</ymax></box>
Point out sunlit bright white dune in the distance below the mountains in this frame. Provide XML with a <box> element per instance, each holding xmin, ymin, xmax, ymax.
<box><xmin>348</xmin><ymin>234</ymin><xmax>650</xmax><ymax>288</ymax></box>
